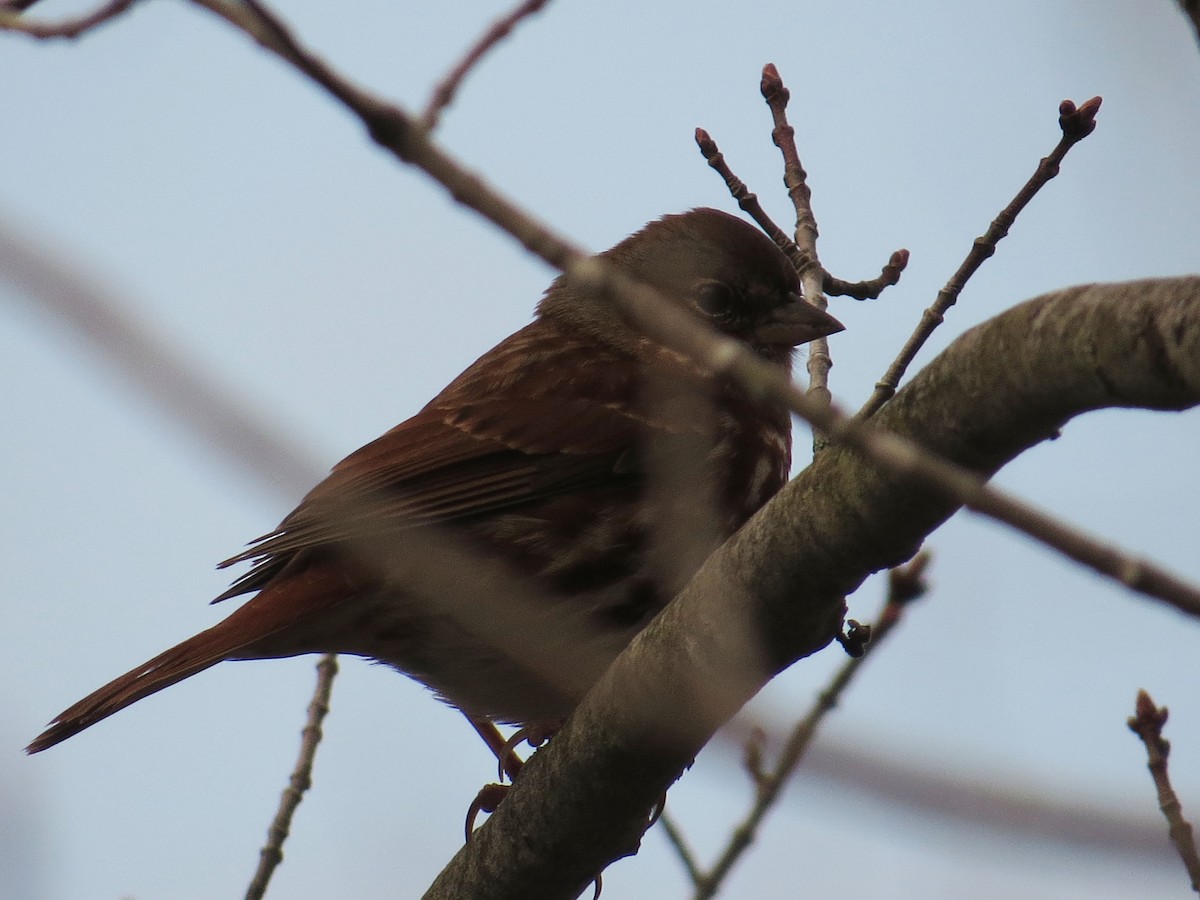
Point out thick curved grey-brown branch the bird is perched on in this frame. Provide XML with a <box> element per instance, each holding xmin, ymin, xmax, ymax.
<box><xmin>426</xmin><ymin>277</ymin><xmax>1200</xmax><ymax>898</ymax></box>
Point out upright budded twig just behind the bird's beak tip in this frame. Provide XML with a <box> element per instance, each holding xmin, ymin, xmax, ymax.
<box><xmin>758</xmin><ymin>62</ymin><xmax>833</xmax><ymax>427</ymax></box>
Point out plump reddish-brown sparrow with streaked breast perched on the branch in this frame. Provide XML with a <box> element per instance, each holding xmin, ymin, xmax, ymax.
<box><xmin>26</xmin><ymin>208</ymin><xmax>842</xmax><ymax>754</ymax></box>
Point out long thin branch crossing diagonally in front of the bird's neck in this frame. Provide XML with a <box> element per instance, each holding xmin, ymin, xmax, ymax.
<box><xmin>180</xmin><ymin>0</ymin><xmax>1200</xmax><ymax>617</ymax></box>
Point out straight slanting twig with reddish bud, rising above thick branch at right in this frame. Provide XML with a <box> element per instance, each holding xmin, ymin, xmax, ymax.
<box><xmin>858</xmin><ymin>97</ymin><xmax>1100</xmax><ymax>419</ymax></box>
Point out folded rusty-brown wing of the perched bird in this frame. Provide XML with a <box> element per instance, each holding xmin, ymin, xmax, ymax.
<box><xmin>214</xmin><ymin>319</ymin><xmax>698</xmax><ymax>602</ymax></box>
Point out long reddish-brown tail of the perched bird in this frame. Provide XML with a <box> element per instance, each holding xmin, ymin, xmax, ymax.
<box><xmin>25</xmin><ymin>568</ymin><xmax>346</xmax><ymax>754</ymax></box>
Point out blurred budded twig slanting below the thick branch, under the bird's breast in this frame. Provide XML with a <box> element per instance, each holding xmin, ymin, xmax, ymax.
<box><xmin>692</xmin><ymin>551</ymin><xmax>930</xmax><ymax>900</ymax></box>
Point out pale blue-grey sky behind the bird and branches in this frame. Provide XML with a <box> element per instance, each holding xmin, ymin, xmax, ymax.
<box><xmin>0</xmin><ymin>0</ymin><xmax>1200</xmax><ymax>900</ymax></box>
